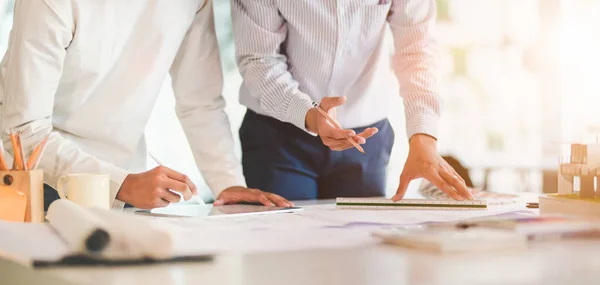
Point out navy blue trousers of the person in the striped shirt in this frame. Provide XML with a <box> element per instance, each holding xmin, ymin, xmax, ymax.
<box><xmin>239</xmin><ymin>110</ymin><xmax>394</xmax><ymax>200</ymax></box>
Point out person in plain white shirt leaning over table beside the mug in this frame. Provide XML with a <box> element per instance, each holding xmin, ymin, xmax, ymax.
<box><xmin>0</xmin><ymin>0</ymin><xmax>290</xmax><ymax>208</ymax></box>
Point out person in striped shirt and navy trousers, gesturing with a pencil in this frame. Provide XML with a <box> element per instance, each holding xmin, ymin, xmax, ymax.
<box><xmin>232</xmin><ymin>0</ymin><xmax>473</xmax><ymax>201</ymax></box>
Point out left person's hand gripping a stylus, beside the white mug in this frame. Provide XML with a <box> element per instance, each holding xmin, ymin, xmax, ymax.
<box><xmin>116</xmin><ymin>166</ymin><xmax>197</xmax><ymax>209</ymax></box>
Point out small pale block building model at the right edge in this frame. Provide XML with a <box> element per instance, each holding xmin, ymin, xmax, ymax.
<box><xmin>558</xmin><ymin>143</ymin><xmax>600</xmax><ymax>198</ymax></box>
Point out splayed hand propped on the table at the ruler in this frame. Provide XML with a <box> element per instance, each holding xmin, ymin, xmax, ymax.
<box><xmin>392</xmin><ymin>134</ymin><xmax>475</xmax><ymax>201</ymax></box>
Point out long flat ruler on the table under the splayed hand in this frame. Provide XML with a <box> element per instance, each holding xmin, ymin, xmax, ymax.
<box><xmin>335</xmin><ymin>198</ymin><xmax>488</xmax><ymax>210</ymax></box>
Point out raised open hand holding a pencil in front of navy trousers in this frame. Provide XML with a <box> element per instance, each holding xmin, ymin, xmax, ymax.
<box><xmin>306</xmin><ymin>97</ymin><xmax>379</xmax><ymax>153</ymax></box>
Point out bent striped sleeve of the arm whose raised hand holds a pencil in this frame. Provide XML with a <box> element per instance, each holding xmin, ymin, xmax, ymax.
<box><xmin>232</xmin><ymin>0</ymin><xmax>312</xmax><ymax>131</ymax></box>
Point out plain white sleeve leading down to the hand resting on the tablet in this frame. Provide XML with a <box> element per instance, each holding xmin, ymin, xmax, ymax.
<box><xmin>171</xmin><ymin>0</ymin><xmax>246</xmax><ymax>198</ymax></box>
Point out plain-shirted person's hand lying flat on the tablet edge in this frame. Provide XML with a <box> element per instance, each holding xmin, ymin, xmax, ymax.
<box><xmin>213</xmin><ymin>186</ymin><xmax>294</xmax><ymax>207</ymax></box>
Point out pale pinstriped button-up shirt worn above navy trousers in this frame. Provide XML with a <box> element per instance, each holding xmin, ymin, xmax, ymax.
<box><xmin>232</xmin><ymin>0</ymin><xmax>441</xmax><ymax>138</ymax></box>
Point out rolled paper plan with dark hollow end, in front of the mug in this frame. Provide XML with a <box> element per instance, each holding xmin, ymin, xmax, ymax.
<box><xmin>46</xmin><ymin>199</ymin><xmax>111</xmax><ymax>255</ymax></box>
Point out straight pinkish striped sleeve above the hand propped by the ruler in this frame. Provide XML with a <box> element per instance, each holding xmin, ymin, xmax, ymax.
<box><xmin>388</xmin><ymin>0</ymin><xmax>442</xmax><ymax>138</ymax></box>
